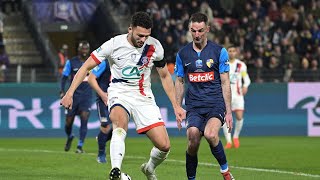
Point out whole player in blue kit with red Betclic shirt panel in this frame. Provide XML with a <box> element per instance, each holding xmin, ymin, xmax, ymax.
<box><xmin>175</xmin><ymin>13</ymin><xmax>234</xmax><ymax>180</ymax></box>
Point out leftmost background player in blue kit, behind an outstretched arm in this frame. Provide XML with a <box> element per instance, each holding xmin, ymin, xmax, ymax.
<box><xmin>60</xmin><ymin>41</ymin><xmax>92</xmax><ymax>153</ymax></box>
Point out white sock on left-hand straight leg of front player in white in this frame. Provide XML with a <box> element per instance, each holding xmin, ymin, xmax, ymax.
<box><xmin>110</xmin><ymin>128</ymin><xmax>127</xmax><ymax>169</ymax></box>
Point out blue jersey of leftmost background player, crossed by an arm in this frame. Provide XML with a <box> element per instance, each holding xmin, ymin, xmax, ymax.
<box><xmin>62</xmin><ymin>56</ymin><xmax>92</xmax><ymax>97</ymax></box>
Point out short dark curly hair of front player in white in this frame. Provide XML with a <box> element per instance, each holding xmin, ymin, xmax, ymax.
<box><xmin>131</xmin><ymin>11</ymin><xmax>153</xmax><ymax>29</ymax></box>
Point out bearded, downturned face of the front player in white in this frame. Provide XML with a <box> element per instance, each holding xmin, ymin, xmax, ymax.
<box><xmin>129</xmin><ymin>26</ymin><xmax>151</xmax><ymax>48</ymax></box>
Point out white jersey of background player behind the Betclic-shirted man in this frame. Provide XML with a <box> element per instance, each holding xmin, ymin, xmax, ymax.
<box><xmin>229</xmin><ymin>59</ymin><xmax>251</xmax><ymax>97</ymax></box>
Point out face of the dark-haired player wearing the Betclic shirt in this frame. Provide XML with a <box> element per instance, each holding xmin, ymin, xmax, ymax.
<box><xmin>189</xmin><ymin>22</ymin><xmax>209</xmax><ymax>43</ymax></box>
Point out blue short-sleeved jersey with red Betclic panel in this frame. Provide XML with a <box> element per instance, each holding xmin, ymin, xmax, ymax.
<box><xmin>175</xmin><ymin>41</ymin><xmax>230</xmax><ymax>111</ymax></box>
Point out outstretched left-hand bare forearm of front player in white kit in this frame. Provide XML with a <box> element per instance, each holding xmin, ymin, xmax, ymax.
<box><xmin>60</xmin><ymin>56</ymin><xmax>97</xmax><ymax>109</ymax></box>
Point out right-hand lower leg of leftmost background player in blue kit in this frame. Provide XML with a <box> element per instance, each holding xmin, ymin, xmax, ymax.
<box><xmin>76</xmin><ymin>111</ymin><xmax>90</xmax><ymax>153</ymax></box>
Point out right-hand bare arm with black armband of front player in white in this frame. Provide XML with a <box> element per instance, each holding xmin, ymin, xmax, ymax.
<box><xmin>155</xmin><ymin>60</ymin><xmax>185</xmax><ymax>126</ymax></box>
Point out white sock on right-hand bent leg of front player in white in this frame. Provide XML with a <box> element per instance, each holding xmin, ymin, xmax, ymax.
<box><xmin>147</xmin><ymin>147</ymin><xmax>170</xmax><ymax>172</ymax></box>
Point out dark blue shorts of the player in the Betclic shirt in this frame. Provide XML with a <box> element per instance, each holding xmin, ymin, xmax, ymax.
<box><xmin>186</xmin><ymin>107</ymin><xmax>225</xmax><ymax>133</ymax></box>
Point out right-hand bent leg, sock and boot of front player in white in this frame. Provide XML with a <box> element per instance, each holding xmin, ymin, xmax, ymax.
<box><xmin>141</xmin><ymin>125</ymin><xmax>170</xmax><ymax>180</ymax></box>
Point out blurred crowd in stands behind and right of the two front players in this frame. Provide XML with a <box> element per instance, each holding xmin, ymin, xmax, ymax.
<box><xmin>113</xmin><ymin>0</ymin><xmax>320</xmax><ymax>83</ymax></box>
